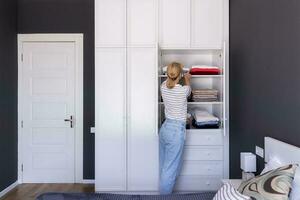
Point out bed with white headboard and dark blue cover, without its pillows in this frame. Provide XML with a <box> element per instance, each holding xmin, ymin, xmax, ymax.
<box><xmin>37</xmin><ymin>137</ymin><xmax>300</xmax><ymax>200</ymax></box>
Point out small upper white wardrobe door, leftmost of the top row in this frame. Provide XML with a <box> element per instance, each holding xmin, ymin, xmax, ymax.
<box><xmin>95</xmin><ymin>0</ymin><xmax>126</xmax><ymax>47</ymax></box>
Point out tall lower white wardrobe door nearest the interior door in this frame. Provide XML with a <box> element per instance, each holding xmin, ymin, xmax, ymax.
<box><xmin>95</xmin><ymin>48</ymin><xmax>126</xmax><ymax>191</ymax></box>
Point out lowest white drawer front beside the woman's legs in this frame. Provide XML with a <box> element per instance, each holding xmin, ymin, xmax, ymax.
<box><xmin>175</xmin><ymin>176</ymin><xmax>222</xmax><ymax>192</ymax></box>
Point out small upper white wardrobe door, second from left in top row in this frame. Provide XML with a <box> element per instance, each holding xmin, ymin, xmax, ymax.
<box><xmin>127</xmin><ymin>0</ymin><xmax>158</xmax><ymax>47</ymax></box>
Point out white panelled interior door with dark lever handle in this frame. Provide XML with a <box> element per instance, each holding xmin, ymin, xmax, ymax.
<box><xmin>20</xmin><ymin>42</ymin><xmax>76</xmax><ymax>183</ymax></box>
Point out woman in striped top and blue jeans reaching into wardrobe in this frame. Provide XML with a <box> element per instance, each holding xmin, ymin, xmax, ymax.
<box><xmin>159</xmin><ymin>62</ymin><xmax>191</xmax><ymax>194</ymax></box>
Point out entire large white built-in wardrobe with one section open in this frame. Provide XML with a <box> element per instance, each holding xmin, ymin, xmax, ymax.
<box><xmin>95</xmin><ymin>0</ymin><xmax>229</xmax><ymax>193</ymax></box>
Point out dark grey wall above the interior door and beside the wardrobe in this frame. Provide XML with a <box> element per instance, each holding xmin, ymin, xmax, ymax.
<box><xmin>18</xmin><ymin>0</ymin><xmax>95</xmax><ymax>179</ymax></box>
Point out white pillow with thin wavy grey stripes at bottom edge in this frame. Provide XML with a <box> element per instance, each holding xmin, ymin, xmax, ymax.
<box><xmin>213</xmin><ymin>183</ymin><xmax>250</xmax><ymax>200</ymax></box>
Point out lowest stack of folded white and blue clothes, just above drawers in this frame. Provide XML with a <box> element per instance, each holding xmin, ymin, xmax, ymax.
<box><xmin>193</xmin><ymin>109</ymin><xmax>220</xmax><ymax>128</ymax></box>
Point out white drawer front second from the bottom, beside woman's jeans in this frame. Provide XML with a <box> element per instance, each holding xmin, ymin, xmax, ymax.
<box><xmin>180</xmin><ymin>161</ymin><xmax>223</xmax><ymax>176</ymax></box>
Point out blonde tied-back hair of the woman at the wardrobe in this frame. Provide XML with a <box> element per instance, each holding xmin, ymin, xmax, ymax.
<box><xmin>166</xmin><ymin>62</ymin><xmax>183</xmax><ymax>89</ymax></box>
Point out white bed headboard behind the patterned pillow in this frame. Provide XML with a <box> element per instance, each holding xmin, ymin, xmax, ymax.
<box><xmin>265</xmin><ymin>137</ymin><xmax>300</xmax><ymax>164</ymax></box>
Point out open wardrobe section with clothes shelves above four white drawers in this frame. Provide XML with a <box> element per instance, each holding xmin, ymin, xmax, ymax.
<box><xmin>158</xmin><ymin>45</ymin><xmax>228</xmax><ymax>191</ymax></box>
